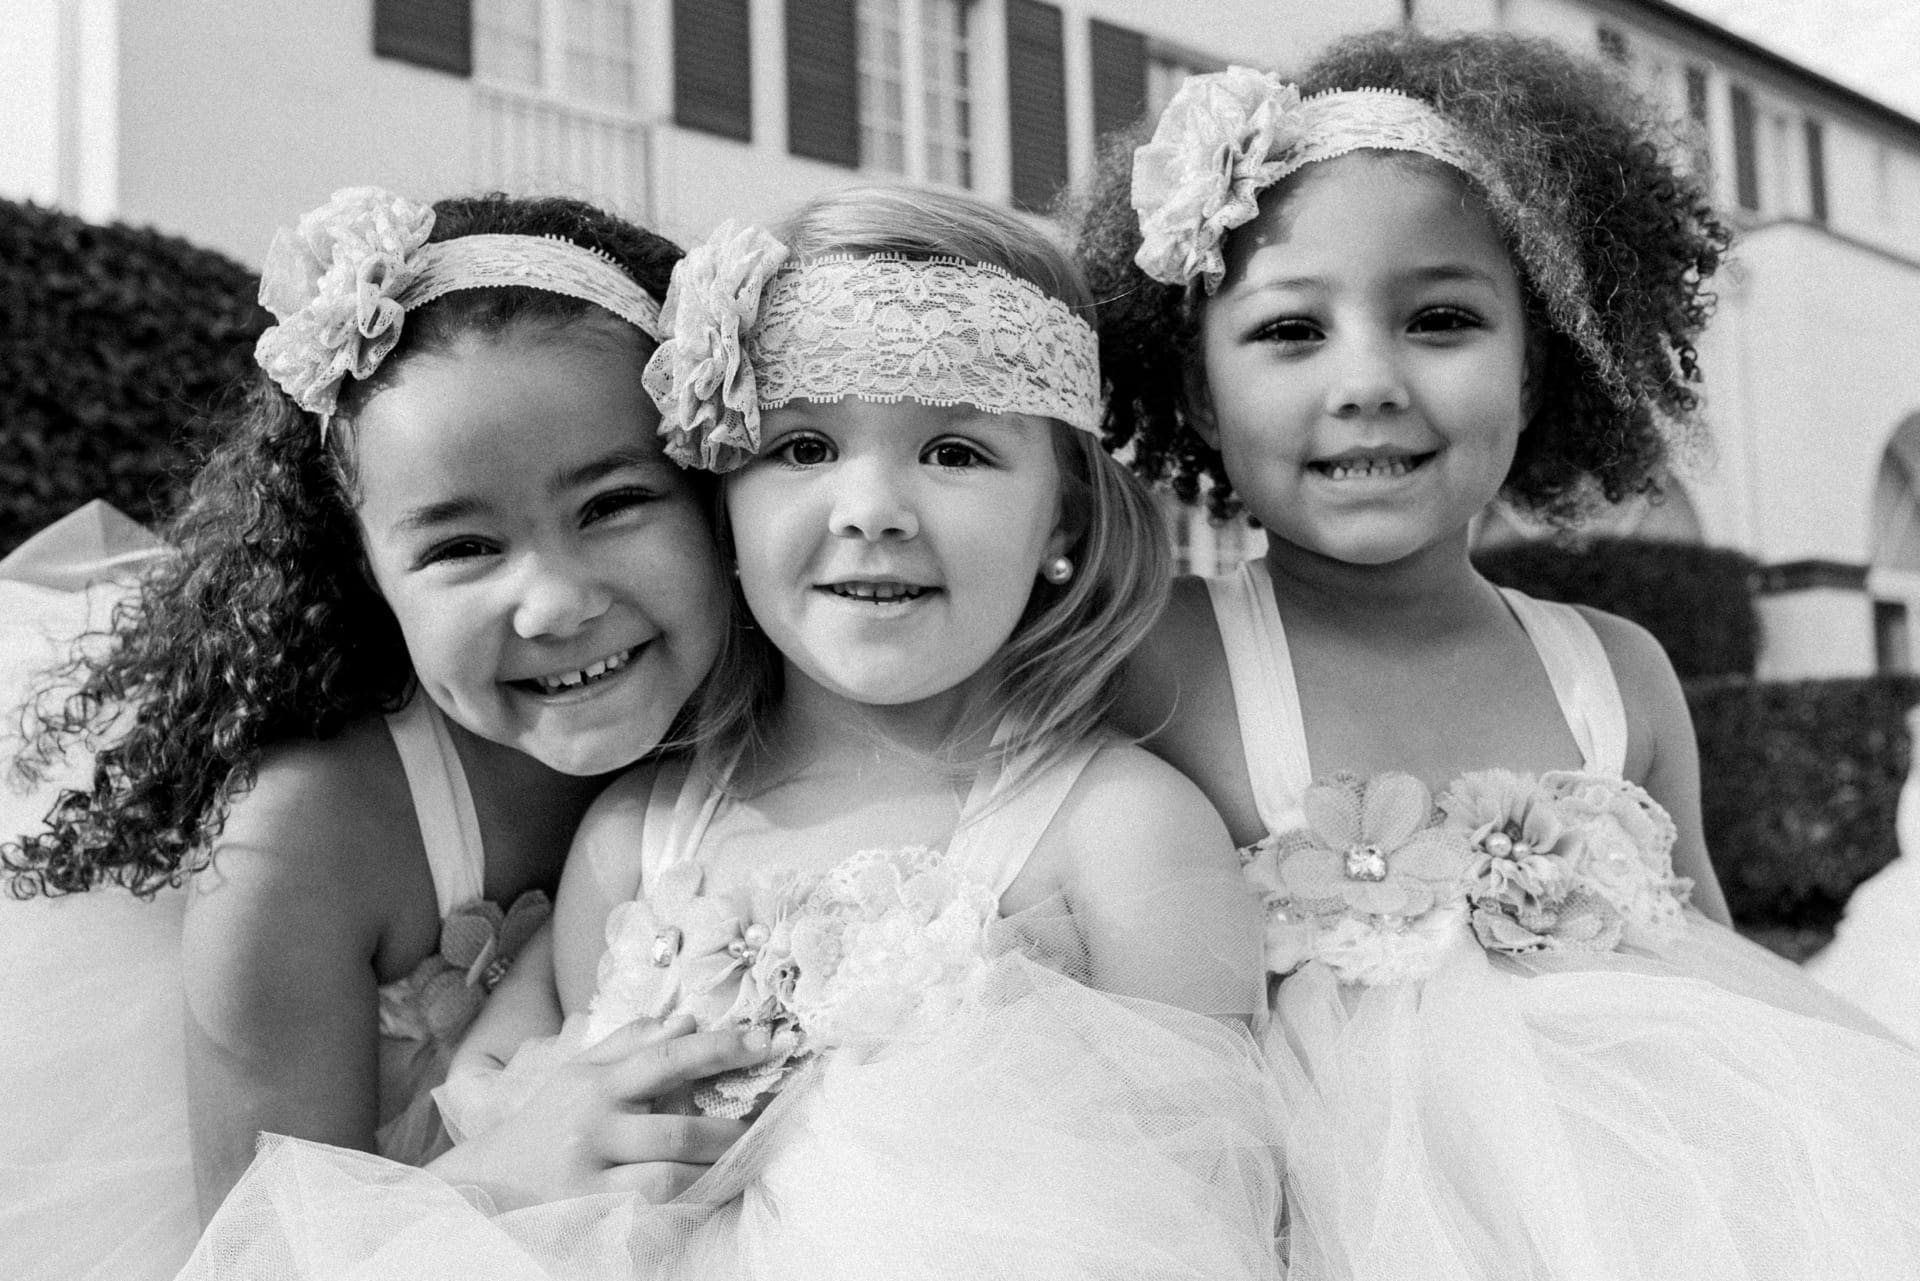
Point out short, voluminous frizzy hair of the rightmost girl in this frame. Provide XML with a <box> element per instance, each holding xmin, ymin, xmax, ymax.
<box><xmin>1066</xmin><ymin>29</ymin><xmax>1730</xmax><ymax>528</ymax></box>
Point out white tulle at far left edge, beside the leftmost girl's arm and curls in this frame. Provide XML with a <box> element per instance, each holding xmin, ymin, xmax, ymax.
<box><xmin>0</xmin><ymin>580</ymin><xmax>200</xmax><ymax>1281</ymax></box>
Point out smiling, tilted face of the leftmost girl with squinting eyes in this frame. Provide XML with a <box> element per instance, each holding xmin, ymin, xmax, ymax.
<box><xmin>353</xmin><ymin>315</ymin><xmax>726</xmax><ymax>774</ymax></box>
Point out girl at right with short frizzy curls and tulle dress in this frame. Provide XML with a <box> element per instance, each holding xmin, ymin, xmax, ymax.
<box><xmin>1083</xmin><ymin>33</ymin><xmax>1920</xmax><ymax>1279</ymax></box>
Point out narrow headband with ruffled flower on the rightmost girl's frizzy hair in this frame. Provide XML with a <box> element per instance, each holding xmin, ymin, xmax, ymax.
<box><xmin>1133</xmin><ymin>67</ymin><xmax>1628</xmax><ymax>398</ymax></box>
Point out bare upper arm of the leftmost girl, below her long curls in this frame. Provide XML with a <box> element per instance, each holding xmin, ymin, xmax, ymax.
<box><xmin>182</xmin><ymin>745</ymin><xmax>410</xmax><ymax>1216</ymax></box>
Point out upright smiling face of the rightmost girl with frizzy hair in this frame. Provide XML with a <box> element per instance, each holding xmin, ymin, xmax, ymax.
<box><xmin>1196</xmin><ymin>152</ymin><xmax>1530</xmax><ymax>565</ymax></box>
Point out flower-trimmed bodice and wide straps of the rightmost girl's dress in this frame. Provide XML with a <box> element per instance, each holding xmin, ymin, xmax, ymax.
<box><xmin>1210</xmin><ymin>563</ymin><xmax>1690</xmax><ymax>985</ymax></box>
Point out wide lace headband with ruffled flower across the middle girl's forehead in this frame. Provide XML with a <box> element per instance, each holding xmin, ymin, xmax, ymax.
<box><xmin>643</xmin><ymin>223</ymin><xmax>1100</xmax><ymax>472</ymax></box>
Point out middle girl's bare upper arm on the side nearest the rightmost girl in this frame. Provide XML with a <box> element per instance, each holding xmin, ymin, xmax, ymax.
<box><xmin>1043</xmin><ymin>747</ymin><xmax>1265</xmax><ymax>1018</ymax></box>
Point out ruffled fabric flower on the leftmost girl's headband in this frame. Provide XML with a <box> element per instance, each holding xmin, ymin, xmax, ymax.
<box><xmin>253</xmin><ymin>186</ymin><xmax>434</xmax><ymax>417</ymax></box>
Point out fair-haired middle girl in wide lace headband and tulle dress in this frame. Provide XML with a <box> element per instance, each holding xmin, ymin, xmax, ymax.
<box><xmin>190</xmin><ymin>188</ymin><xmax>1277</xmax><ymax>1277</ymax></box>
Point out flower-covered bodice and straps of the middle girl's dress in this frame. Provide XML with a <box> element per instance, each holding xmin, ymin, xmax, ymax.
<box><xmin>586</xmin><ymin>745</ymin><xmax>1096</xmax><ymax>1116</ymax></box>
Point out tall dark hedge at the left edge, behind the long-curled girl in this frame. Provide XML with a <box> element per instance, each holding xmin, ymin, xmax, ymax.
<box><xmin>0</xmin><ymin>200</ymin><xmax>271</xmax><ymax>555</ymax></box>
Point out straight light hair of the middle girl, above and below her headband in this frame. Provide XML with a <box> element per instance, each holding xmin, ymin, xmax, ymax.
<box><xmin>701</xmin><ymin>186</ymin><xmax>1173</xmax><ymax>784</ymax></box>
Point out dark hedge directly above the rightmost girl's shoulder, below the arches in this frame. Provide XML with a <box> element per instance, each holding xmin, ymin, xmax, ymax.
<box><xmin>1473</xmin><ymin>538</ymin><xmax>1761</xmax><ymax>680</ymax></box>
